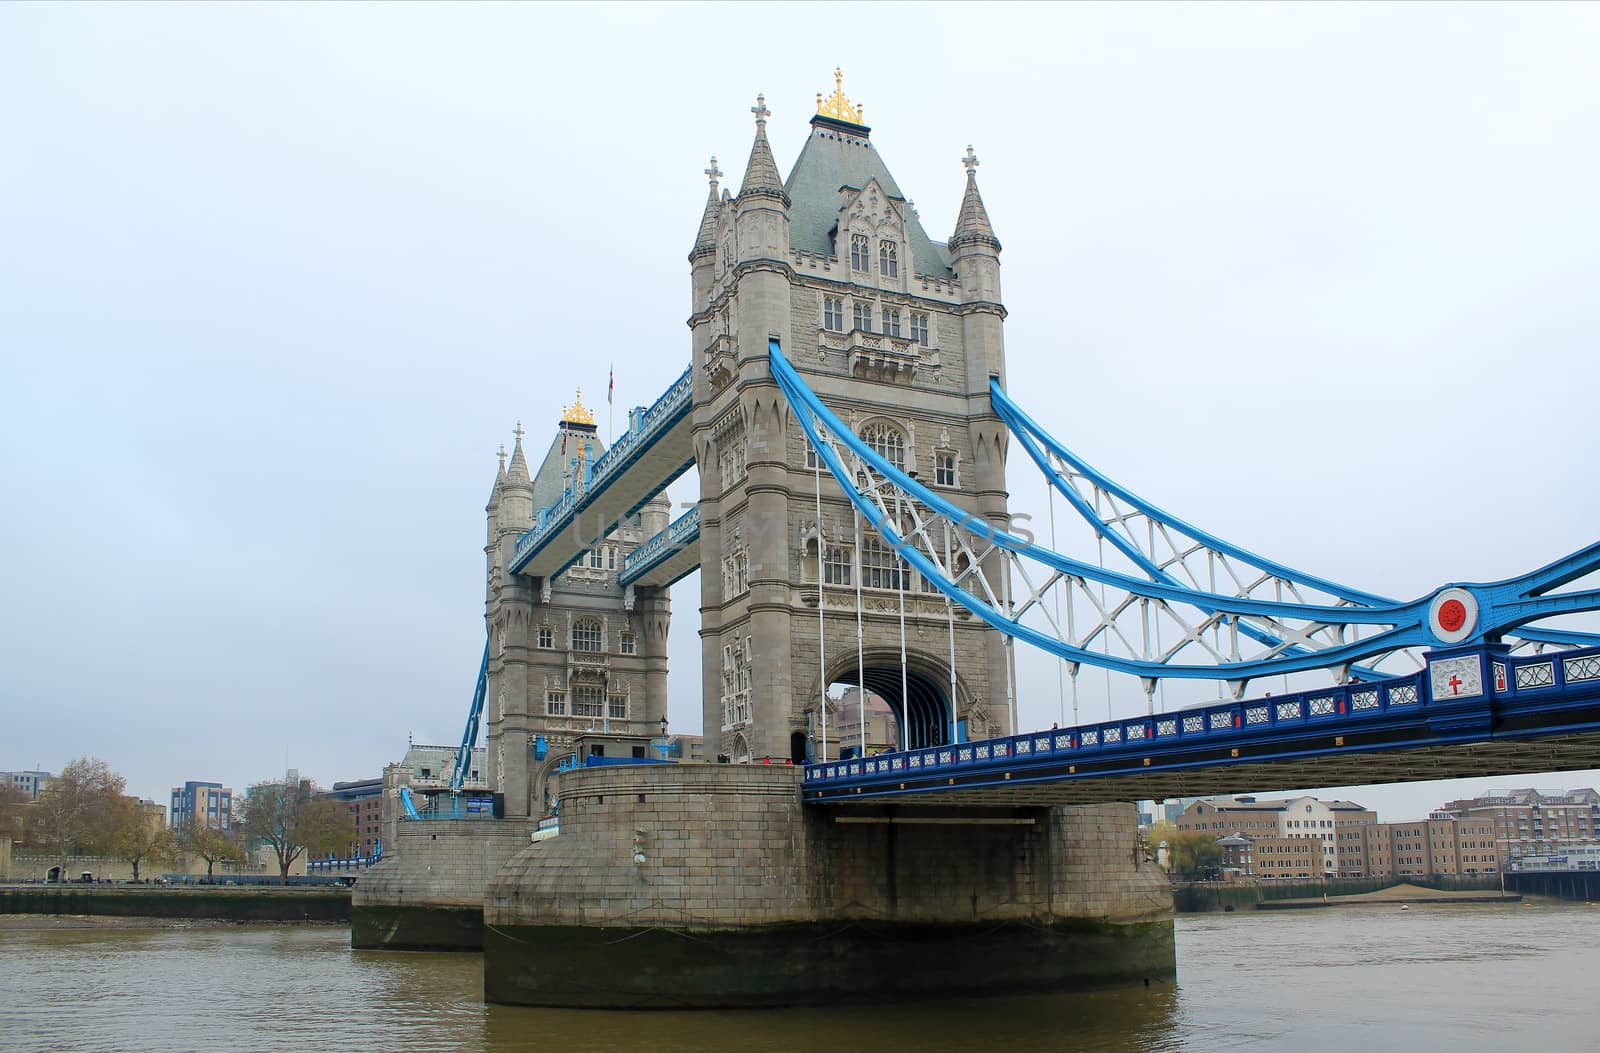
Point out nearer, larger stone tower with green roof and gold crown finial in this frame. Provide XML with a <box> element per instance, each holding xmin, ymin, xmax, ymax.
<box><xmin>688</xmin><ymin>70</ymin><xmax>1008</xmax><ymax>762</ymax></box>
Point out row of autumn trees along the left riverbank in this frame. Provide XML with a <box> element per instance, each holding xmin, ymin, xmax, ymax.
<box><xmin>0</xmin><ymin>757</ymin><xmax>355</xmax><ymax>882</ymax></box>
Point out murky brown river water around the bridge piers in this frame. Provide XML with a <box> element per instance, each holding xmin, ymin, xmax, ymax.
<box><xmin>0</xmin><ymin>904</ymin><xmax>1600</xmax><ymax>1053</ymax></box>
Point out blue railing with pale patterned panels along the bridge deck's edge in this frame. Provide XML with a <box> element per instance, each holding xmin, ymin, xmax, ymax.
<box><xmin>805</xmin><ymin>648</ymin><xmax>1600</xmax><ymax>787</ymax></box>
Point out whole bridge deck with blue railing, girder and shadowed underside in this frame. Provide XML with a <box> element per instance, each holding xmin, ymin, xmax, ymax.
<box><xmin>805</xmin><ymin>648</ymin><xmax>1600</xmax><ymax>805</ymax></box>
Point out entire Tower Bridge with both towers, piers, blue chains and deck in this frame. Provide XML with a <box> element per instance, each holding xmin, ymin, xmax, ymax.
<box><xmin>355</xmin><ymin>70</ymin><xmax>1600</xmax><ymax>1007</ymax></box>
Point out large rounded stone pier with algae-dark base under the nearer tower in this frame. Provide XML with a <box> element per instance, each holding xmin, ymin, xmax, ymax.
<box><xmin>483</xmin><ymin>765</ymin><xmax>1174</xmax><ymax>1008</ymax></box>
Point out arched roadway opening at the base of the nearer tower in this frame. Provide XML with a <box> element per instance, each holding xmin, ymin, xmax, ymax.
<box><xmin>829</xmin><ymin>655</ymin><xmax>952</xmax><ymax>755</ymax></box>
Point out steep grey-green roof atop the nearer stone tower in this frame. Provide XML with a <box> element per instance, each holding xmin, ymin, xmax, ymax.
<box><xmin>784</xmin><ymin>118</ymin><xmax>950</xmax><ymax>277</ymax></box>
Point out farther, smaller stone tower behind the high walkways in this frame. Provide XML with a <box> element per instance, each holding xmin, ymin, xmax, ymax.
<box><xmin>483</xmin><ymin>392</ymin><xmax>672</xmax><ymax>816</ymax></box>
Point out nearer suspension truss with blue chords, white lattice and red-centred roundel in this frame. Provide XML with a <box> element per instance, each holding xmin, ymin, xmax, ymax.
<box><xmin>768</xmin><ymin>332</ymin><xmax>1600</xmax><ymax>684</ymax></box>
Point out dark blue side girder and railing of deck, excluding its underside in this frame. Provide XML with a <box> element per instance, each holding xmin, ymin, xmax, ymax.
<box><xmin>805</xmin><ymin>647</ymin><xmax>1600</xmax><ymax>803</ymax></box>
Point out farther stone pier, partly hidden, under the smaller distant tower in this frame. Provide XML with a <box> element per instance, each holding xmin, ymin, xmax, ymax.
<box><xmin>350</xmin><ymin>819</ymin><xmax>538</xmax><ymax>951</ymax></box>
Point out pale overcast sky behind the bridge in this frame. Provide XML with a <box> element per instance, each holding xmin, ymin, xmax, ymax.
<box><xmin>0</xmin><ymin>3</ymin><xmax>1600</xmax><ymax>818</ymax></box>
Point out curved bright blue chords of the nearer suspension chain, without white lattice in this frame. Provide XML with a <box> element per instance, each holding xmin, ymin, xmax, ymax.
<box><xmin>768</xmin><ymin>339</ymin><xmax>1600</xmax><ymax>680</ymax></box>
